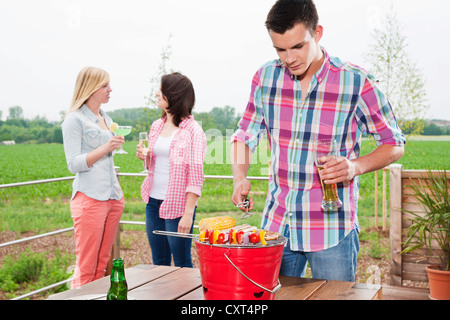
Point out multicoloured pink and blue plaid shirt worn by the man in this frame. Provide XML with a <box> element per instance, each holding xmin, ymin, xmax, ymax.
<box><xmin>231</xmin><ymin>48</ymin><xmax>405</xmax><ymax>252</ymax></box>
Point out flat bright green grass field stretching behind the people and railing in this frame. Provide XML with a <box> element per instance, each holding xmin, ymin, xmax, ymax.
<box><xmin>0</xmin><ymin>137</ymin><xmax>450</xmax><ymax>233</ymax></box>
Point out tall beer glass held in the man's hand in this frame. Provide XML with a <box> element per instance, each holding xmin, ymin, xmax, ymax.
<box><xmin>314</xmin><ymin>139</ymin><xmax>342</xmax><ymax>210</ymax></box>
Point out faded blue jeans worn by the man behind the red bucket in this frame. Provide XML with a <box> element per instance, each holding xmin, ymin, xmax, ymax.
<box><xmin>280</xmin><ymin>229</ymin><xmax>359</xmax><ymax>281</ymax></box>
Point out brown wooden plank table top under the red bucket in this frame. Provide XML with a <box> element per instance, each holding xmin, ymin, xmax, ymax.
<box><xmin>48</xmin><ymin>265</ymin><xmax>382</xmax><ymax>300</ymax></box>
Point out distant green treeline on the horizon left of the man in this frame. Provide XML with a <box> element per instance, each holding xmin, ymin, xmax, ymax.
<box><xmin>0</xmin><ymin>106</ymin><xmax>240</xmax><ymax>143</ymax></box>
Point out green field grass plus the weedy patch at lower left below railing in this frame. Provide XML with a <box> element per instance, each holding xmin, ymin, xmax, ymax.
<box><xmin>0</xmin><ymin>137</ymin><xmax>450</xmax><ymax>299</ymax></box>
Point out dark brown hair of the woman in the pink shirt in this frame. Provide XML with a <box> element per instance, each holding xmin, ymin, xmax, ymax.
<box><xmin>161</xmin><ymin>72</ymin><xmax>195</xmax><ymax>127</ymax></box>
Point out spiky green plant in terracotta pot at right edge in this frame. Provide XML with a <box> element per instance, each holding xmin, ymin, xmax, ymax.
<box><xmin>402</xmin><ymin>169</ymin><xmax>450</xmax><ymax>300</ymax></box>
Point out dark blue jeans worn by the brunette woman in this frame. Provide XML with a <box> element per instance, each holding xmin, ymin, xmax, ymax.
<box><xmin>145</xmin><ymin>198</ymin><xmax>196</xmax><ymax>268</ymax></box>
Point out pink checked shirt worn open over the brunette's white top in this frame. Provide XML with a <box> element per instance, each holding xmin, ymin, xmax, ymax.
<box><xmin>141</xmin><ymin>115</ymin><xmax>206</xmax><ymax>219</ymax></box>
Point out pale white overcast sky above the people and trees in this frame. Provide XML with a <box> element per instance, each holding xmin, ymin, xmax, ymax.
<box><xmin>0</xmin><ymin>0</ymin><xmax>450</xmax><ymax>120</ymax></box>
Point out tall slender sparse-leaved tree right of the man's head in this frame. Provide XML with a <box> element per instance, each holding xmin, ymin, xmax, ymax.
<box><xmin>365</xmin><ymin>6</ymin><xmax>429</xmax><ymax>134</ymax></box>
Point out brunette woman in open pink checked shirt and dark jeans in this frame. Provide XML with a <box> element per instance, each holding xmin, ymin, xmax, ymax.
<box><xmin>136</xmin><ymin>73</ymin><xmax>206</xmax><ymax>267</ymax></box>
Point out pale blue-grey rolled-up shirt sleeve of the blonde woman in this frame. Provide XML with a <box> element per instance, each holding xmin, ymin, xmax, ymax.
<box><xmin>61</xmin><ymin>114</ymin><xmax>89</xmax><ymax>174</ymax></box>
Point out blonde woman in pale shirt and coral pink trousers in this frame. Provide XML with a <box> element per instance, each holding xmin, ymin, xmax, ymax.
<box><xmin>62</xmin><ymin>67</ymin><xmax>124</xmax><ymax>288</ymax></box>
